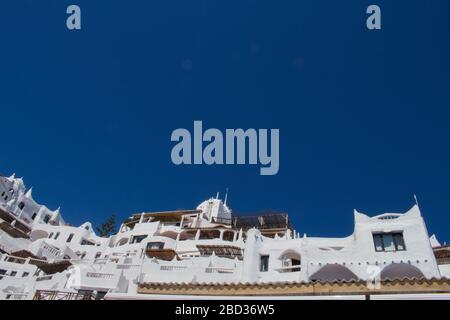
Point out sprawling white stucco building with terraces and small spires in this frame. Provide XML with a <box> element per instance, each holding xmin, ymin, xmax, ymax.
<box><xmin>0</xmin><ymin>175</ymin><xmax>450</xmax><ymax>299</ymax></box>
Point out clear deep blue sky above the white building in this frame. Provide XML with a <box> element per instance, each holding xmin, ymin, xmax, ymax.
<box><xmin>0</xmin><ymin>0</ymin><xmax>450</xmax><ymax>241</ymax></box>
